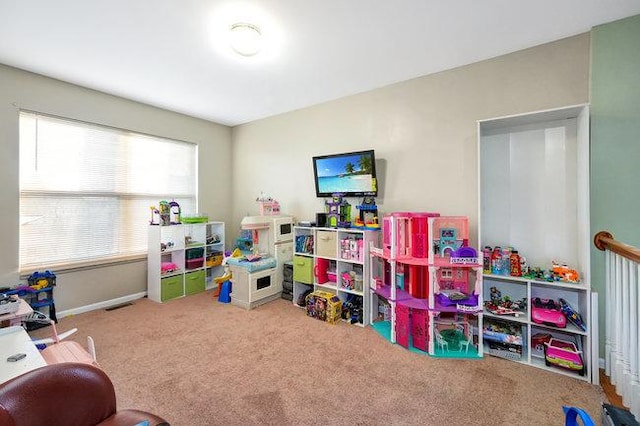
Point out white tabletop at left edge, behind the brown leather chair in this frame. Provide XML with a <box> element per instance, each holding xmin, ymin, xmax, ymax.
<box><xmin>0</xmin><ymin>326</ymin><xmax>47</xmax><ymax>383</ymax></box>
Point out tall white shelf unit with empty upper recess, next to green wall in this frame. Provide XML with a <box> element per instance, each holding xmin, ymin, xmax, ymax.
<box><xmin>478</xmin><ymin>105</ymin><xmax>598</xmax><ymax>384</ymax></box>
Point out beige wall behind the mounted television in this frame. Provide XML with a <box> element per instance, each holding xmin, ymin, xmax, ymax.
<box><xmin>227</xmin><ymin>34</ymin><xmax>589</xmax><ymax>243</ymax></box>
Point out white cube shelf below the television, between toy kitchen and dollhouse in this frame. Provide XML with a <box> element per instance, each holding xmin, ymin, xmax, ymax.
<box><xmin>293</xmin><ymin>226</ymin><xmax>380</xmax><ymax>326</ymax></box>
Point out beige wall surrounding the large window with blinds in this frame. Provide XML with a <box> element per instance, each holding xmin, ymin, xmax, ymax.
<box><xmin>0</xmin><ymin>65</ymin><xmax>231</xmax><ymax>311</ymax></box>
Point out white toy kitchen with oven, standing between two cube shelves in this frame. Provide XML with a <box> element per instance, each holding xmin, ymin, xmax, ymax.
<box><xmin>227</xmin><ymin>215</ymin><xmax>294</xmax><ymax>309</ymax></box>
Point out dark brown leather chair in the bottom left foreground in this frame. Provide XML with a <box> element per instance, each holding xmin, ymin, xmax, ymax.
<box><xmin>0</xmin><ymin>363</ymin><xmax>169</xmax><ymax>426</ymax></box>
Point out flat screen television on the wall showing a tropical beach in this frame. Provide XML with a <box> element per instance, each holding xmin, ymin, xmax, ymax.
<box><xmin>313</xmin><ymin>149</ymin><xmax>378</xmax><ymax>197</ymax></box>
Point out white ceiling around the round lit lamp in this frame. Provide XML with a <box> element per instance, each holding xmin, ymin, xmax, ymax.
<box><xmin>0</xmin><ymin>0</ymin><xmax>640</xmax><ymax>125</ymax></box>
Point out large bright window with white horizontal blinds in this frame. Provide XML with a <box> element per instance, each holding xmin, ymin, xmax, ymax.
<box><xmin>20</xmin><ymin>112</ymin><xmax>197</xmax><ymax>273</ymax></box>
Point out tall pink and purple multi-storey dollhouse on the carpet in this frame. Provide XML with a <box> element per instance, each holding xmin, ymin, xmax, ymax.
<box><xmin>371</xmin><ymin>212</ymin><xmax>482</xmax><ymax>358</ymax></box>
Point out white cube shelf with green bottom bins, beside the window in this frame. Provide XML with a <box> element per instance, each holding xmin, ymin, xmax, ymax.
<box><xmin>147</xmin><ymin>222</ymin><xmax>224</xmax><ymax>302</ymax></box>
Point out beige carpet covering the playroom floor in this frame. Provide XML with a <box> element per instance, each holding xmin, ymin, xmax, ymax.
<box><xmin>32</xmin><ymin>292</ymin><xmax>605</xmax><ymax>426</ymax></box>
